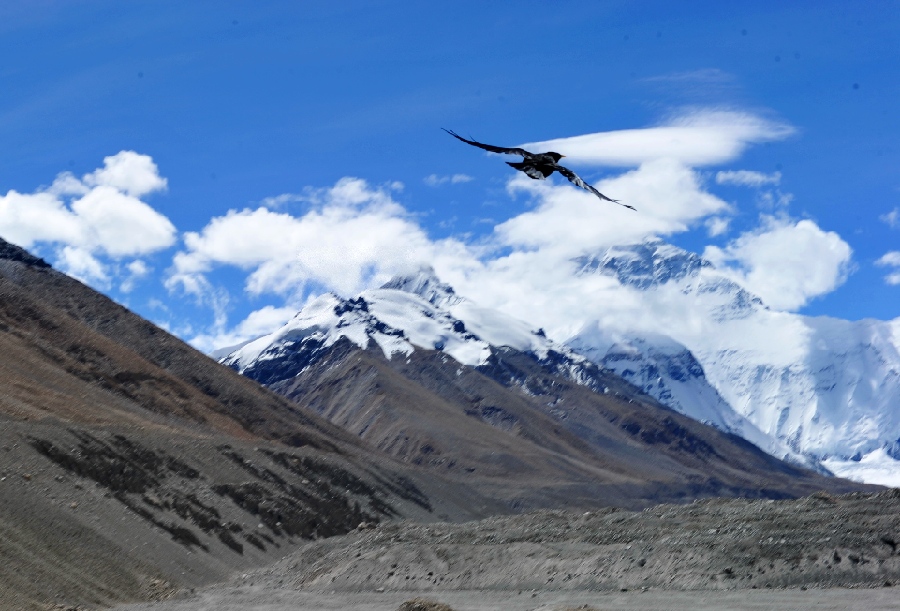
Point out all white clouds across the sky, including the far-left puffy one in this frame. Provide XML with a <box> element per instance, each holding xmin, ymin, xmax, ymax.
<box><xmin>0</xmin><ymin>110</ymin><xmax>856</xmax><ymax>351</ymax></box>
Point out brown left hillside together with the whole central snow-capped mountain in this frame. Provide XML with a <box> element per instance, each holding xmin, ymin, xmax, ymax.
<box><xmin>0</xmin><ymin>233</ymin><xmax>884</xmax><ymax>609</ymax></box>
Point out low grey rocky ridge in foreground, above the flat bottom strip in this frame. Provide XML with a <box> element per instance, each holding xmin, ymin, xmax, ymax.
<box><xmin>236</xmin><ymin>490</ymin><xmax>900</xmax><ymax>591</ymax></box>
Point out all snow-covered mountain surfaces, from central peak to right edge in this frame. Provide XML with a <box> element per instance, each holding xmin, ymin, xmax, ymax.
<box><xmin>220</xmin><ymin>240</ymin><xmax>900</xmax><ymax>485</ymax></box>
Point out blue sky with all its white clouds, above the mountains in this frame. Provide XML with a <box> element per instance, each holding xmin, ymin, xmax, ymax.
<box><xmin>0</xmin><ymin>0</ymin><xmax>900</xmax><ymax>351</ymax></box>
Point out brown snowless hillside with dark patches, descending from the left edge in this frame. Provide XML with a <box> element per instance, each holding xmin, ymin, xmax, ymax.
<box><xmin>0</xmin><ymin>240</ymin><xmax>492</xmax><ymax>609</ymax></box>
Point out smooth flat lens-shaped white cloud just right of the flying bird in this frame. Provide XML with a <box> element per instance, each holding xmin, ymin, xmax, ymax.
<box><xmin>523</xmin><ymin>110</ymin><xmax>795</xmax><ymax>167</ymax></box>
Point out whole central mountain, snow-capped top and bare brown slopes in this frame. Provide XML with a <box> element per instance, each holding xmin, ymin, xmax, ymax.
<box><xmin>221</xmin><ymin>270</ymin><xmax>864</xmax><ymax>509</ymax></box>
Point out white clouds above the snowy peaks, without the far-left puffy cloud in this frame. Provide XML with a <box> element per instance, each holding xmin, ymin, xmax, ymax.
<box><xmin>167</xmin><ymin>111</ymin><xmax>852</xmax><ymax>350</ymax></box>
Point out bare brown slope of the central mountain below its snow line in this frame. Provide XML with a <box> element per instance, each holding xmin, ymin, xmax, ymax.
<box><xmin>271</xmin><ymin>340</ymin><xmax>874</xmax><ymax>509</ymax></box>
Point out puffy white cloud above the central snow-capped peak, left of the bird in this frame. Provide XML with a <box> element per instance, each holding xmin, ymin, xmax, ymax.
<box><xmin>166</xmin><ymin>178</ymin><xmax>478</xmax><ymax>306</ymax></box>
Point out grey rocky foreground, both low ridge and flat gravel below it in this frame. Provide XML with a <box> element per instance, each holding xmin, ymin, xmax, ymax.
<box><xmin>116</xmin><ymin>490</ymin><xmax>900</xmax><ymax>611</ymax></box>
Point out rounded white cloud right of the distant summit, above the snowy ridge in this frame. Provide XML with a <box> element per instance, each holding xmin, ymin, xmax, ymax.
<box><xmin>703</xmin><ymin>217</ymin><xmax>852</xmax><ymax>310</ymax></box>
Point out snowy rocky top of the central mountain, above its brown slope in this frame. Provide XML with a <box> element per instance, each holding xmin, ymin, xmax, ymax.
<box><xmin>219</xmin><ymin>269</ymin><xmax>621</xmax><ymax>400</ymax></box>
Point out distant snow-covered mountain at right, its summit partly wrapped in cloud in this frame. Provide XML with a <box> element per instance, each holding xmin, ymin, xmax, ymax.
<box><xmin>573</xmin><ymin>241</ymin><xmax>900</xmax><ymax>485</ymax></box>
